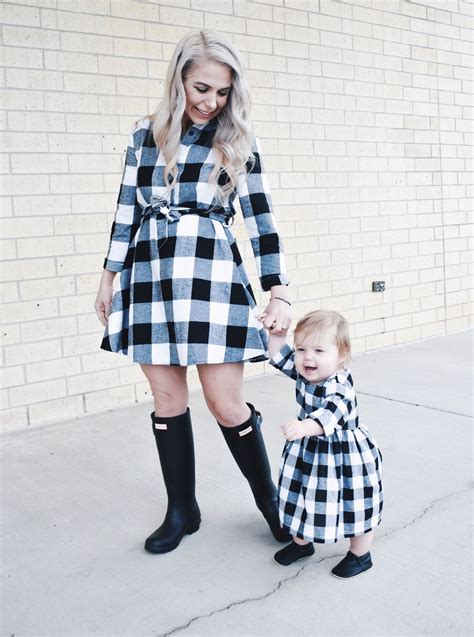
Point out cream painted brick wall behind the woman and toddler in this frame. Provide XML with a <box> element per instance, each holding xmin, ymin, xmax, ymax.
<box><xmin>1</xmin><ymin>0</ymin><xmax>473</xmax><ymax>429</ymax></box>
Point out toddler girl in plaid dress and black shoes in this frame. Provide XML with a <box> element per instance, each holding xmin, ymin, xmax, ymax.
<box><xmin>260</xmin><ymin>311</ymin><xmax>383</xmax><ymax>578</ymax></box>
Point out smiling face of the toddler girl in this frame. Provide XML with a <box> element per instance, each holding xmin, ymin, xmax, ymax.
<box><xmin>295</xmin><ymin>331</ymin><xmax>343</xmax><ymax>383</ymax></box>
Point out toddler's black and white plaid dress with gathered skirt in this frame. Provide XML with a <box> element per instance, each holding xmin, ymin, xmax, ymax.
<box><xmin>270</xmin><ymin>345</ymin><xmax>383</xmax><ymax>542</ymax></box>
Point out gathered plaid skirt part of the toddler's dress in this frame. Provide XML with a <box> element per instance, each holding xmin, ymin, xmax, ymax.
<box><xmin>279</xmin><ymin>425</ymin><xmax>383</xmax><ymax>543</ymax></box>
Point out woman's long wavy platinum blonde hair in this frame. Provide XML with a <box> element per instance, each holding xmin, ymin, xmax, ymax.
<box><xmin>153</xmin><ymin>30</ymin><xmax>254</xmax><ymax>203</ymax></box>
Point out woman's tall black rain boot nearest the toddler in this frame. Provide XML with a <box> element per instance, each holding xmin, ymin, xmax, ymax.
<box><xmin>219</xmin><ymin>403</ymin><xmax>291</xmax><ymax>542</ymax></box>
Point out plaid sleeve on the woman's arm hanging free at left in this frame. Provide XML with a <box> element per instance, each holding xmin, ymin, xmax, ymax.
<box><xmin>104</xmin><ymin>122</ymin><xmax>143</xmax><ymax>272</ymax></box>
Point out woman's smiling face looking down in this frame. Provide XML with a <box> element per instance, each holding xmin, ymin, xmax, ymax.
<box><xmin>184</xmin><ymin>62</ymin><xmax>232</xmax><ymax>125</ymax></box>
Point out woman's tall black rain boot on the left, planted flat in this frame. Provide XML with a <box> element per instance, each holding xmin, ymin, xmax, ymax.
<box><xmin>145</xmin><ymin>409</ymin><xmax>201</xmax><ymax>553</ymax></box>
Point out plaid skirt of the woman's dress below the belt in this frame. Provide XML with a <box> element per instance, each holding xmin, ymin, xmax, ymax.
<box><xmin>101</xmin><ymin>211</ymin><xmax>267</xmax><ymax>366</ymax></box>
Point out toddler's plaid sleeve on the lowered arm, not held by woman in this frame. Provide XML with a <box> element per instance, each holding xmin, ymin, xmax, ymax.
<box><xmin>308</xmin><ymin>378</ymin><xmax>356</xmax><ymax>436</ymax></box>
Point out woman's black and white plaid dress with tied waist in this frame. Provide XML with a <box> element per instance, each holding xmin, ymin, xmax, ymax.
<box><xmin>101</xmin><ymin>118</ymin><xmax>288</xmax><ymax>366</ymax></box>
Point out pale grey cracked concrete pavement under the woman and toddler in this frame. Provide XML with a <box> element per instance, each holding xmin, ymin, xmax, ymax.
<box><xmin>2</xmin><ymin>332</ymin><xmax>472</xmax><ymax>637</ymax></box>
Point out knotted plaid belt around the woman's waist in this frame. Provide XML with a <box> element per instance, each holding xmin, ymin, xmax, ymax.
<box><xmin>141</xmin><ymin>195</ymin><xmax>234</xmax><ymax>248</ymax></box>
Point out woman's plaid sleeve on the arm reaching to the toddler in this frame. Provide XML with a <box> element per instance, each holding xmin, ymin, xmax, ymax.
<box><xmin>237</xmin><ymin>139</ymin><xmax>288</xmax><ymax>291</ymax></box>
